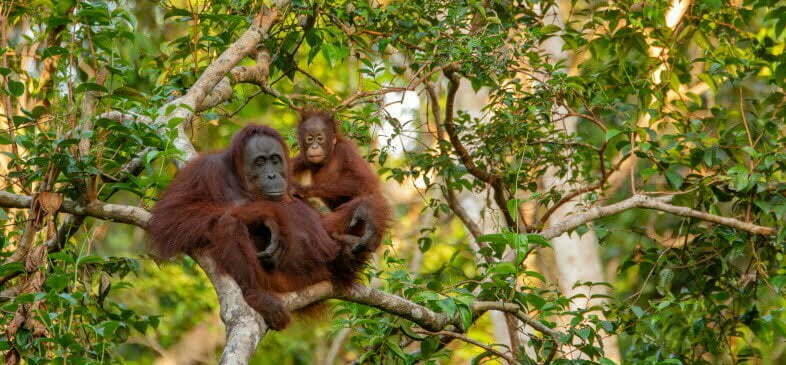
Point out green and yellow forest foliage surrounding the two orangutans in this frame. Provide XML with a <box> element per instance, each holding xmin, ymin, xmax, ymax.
<box><xmin>0</xmin><ymin>0</ymin><xmax>786</xmax><ymax>365</ymax></box>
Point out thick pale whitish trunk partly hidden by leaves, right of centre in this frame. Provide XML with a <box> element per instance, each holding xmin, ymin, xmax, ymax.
<box><xmin>542</xmin><ymin>1</ymin><xmax>620</xmax><ymax>361</ymax></box>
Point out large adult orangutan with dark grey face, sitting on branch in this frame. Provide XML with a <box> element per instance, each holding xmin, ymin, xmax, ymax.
<box><xmin>148</xmin><ymin>125</ymin><xmax>375</xmax><ymax>330</ymax></box>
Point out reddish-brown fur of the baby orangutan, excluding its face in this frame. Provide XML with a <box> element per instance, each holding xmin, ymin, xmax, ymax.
<box><xmin>292</xmin><ymin>109</ymin><xmax>391</xmax><ymax>252</ymax></box>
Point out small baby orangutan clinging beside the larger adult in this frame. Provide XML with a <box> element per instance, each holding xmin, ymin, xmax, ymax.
<box><xmin>293</xmin><ymin>109</ymin><xmax>390</xmax><ymax>252</ymax></box>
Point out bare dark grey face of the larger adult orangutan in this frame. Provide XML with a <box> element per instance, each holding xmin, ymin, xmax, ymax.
<box><xmin>243</xmin><ymin>135</ymin><xmax>287</xmax><ymax>200</ymax></box>
